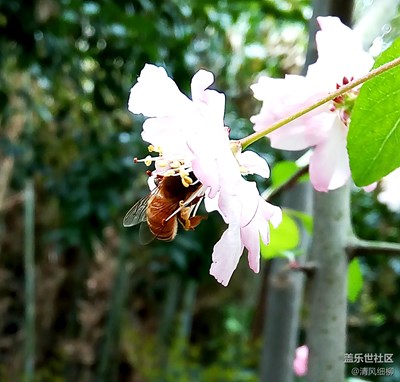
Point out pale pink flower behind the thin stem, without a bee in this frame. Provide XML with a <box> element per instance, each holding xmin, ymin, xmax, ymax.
<box><xmin>251</xmin><ymin>17</ymin><xmax>373</xmax><ymax>192</ymax></box>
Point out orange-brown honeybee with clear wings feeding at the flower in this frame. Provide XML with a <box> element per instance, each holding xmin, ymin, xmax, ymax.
<box><xmin>123</xmin><ymin>174</ymin><xmax>205</xmax><ymax>244</ymax></box>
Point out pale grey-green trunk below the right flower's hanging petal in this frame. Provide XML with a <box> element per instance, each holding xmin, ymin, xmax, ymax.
<box><xmin>307</xmin><ymin>185</ymin><xmax>351</xmax><ymax>382</ymax></box>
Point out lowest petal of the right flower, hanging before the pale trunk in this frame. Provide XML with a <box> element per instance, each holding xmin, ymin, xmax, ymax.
<box><xmin>310</xmin><ymin>117</ymin><xmax>350</xmax><ymax>192</ymax></box>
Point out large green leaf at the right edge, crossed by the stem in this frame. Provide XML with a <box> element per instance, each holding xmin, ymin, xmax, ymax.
<box><xmin>347</xmin><ymin>38</ymin><xmax>400</xmax><ymax>186</ymax></box>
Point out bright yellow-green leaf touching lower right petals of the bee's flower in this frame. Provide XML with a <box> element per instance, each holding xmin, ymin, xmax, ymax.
<box><xmin>260</xmin><ymin>211</ymin><xmax>300</xmax><ymax>259</ymax></box>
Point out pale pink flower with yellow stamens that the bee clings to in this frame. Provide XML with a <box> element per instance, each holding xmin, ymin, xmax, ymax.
<box><xmin>128</xmin><ymin>64</ymin><xmax>281</xmax><ymax>286</ymax></box>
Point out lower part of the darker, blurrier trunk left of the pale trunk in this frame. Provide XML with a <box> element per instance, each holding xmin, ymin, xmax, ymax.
<box><xmin>261</xmin><ymin>177</ymin><xmax>311</xmax><ymax>382</ymax></box>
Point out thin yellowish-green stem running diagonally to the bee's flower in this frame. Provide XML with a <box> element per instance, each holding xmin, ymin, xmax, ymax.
<box><xmin>239</xmin><ymin>57</ymin><xmax>400</xmax><ymax>150</ymax></box>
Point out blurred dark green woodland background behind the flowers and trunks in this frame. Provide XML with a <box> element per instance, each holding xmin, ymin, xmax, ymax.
<box><xmin>0</xmin><ymin>0</ymin><xmax>400</xmax><ymax>382</ymax></box>
